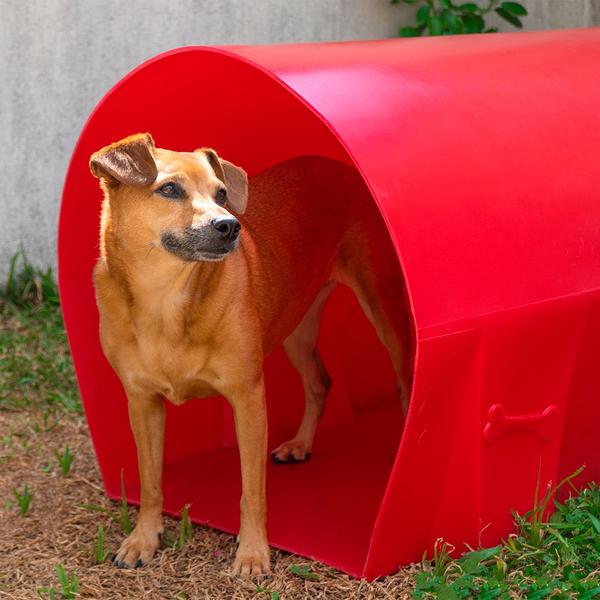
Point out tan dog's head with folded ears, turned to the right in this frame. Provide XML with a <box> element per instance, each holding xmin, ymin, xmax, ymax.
<box><xmin>90</xmin><ymin>133</ymin><xmax>248</xmax><ymax>261</ymax></box>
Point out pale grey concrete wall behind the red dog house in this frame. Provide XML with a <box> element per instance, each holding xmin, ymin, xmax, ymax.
<box><xmin>0</xmin><ymin>0</ymin><xmax>600</xmax><ymax>277</ymax></box>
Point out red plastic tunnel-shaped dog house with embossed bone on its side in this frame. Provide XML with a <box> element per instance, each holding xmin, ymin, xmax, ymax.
<box><xmin>59</xmin><ymin>30</ymin><xmax>600</xmax><ymax>578</ymax></box>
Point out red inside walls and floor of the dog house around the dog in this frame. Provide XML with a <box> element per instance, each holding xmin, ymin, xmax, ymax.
<box><xmin>59</xmin><ymin>50</ymin><xmax>412</xmax><ymax>575</ymax></box>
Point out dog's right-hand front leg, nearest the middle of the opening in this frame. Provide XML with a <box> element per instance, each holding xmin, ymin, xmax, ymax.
<box><xmin>231</xmin><ymin>380</ymin><xmax>270</xmax><ymax>577</ymax></box>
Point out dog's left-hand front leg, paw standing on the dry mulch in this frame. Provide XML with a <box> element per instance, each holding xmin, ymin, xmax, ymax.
<box><xmin>114</xmin><ymin>393</ymin><xmax>165</xmax><ymax>567</ymax></box>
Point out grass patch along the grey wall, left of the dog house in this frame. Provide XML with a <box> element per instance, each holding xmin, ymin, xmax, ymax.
<box><xmin>0</xmin><ymin>252</ymin><xmax>82</xmax><ymax>414</ymax></box>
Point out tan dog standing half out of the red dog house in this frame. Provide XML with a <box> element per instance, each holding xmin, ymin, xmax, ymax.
<box><xmin>90</xmin><ymin>134</ymin><xmax>411</xmax><ymax>575</ymax></box>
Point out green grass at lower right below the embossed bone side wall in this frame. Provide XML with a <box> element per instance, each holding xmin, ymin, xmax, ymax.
<box><xmin>414</xmin><ymin>469</ymin><xmax>600</xmax><ymax>600</ymax></box>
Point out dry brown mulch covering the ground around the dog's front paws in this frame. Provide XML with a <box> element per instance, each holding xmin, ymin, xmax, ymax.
<box><xmin>0</xmin><ymin>412</ymin><xmax>415</xmax><ymax>600</ymax></box>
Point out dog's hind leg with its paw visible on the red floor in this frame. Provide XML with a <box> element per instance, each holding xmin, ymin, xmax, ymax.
<box><xmin>271</xmin><ymin>281</ymin><xmax>337</xmax><ymax>463</ymax></box>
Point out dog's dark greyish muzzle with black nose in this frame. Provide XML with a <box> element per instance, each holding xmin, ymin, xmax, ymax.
<box><xmin>161</xmin><ymin>217</ymin><xmax>241</xmax><ymax>261</ymax></box>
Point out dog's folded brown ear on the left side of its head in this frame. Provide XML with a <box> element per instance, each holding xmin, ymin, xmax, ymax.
<box><xmin>90</xmin><ymin>133</ymin><xmax>158</xmax><ymax>187</ymax></box>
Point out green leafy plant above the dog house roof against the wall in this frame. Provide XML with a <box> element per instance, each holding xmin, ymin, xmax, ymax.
<box><xmin>390</xmin><ymin>0</ymin><xmax>527</xmax><ymax>37</ymax></box>
